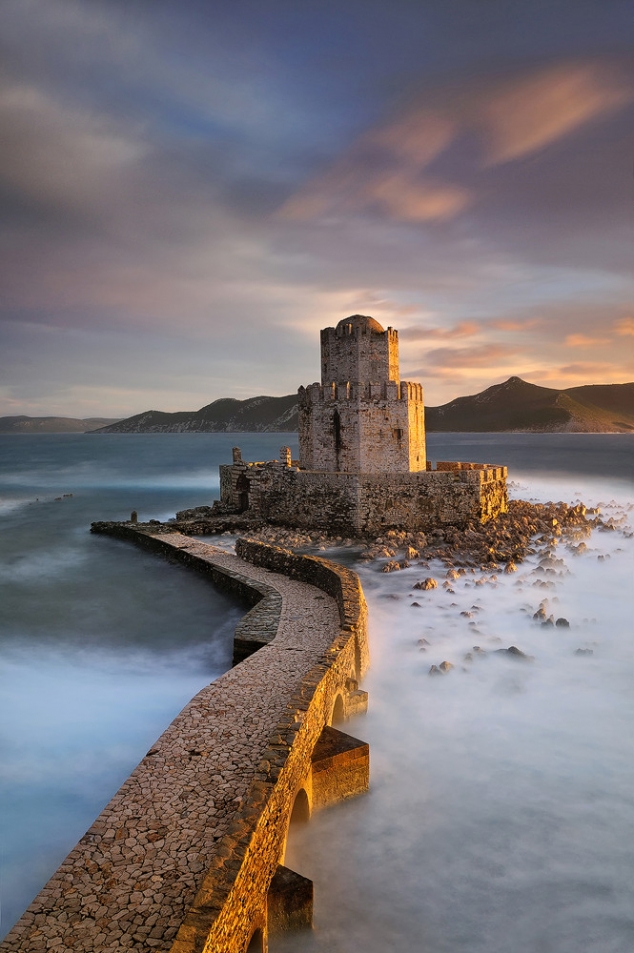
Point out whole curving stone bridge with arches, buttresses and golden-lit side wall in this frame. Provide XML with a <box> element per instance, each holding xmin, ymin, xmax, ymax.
<box><xmin>0</xmin><ymin>523</ymin><xmax>369</xmax><ymax>953</ymax></box>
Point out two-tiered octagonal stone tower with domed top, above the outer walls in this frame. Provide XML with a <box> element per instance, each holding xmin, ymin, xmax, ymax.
<box><xmin>299</xmin><ymin>314</ymin><xmax>426</xmax><ymax>473</ymax></box>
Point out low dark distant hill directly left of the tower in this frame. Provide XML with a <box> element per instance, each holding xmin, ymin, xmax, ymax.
<box><xmin>97</xmin><ymin>394</ymin><xmax>297</xmax><ymax>433</ymax></box>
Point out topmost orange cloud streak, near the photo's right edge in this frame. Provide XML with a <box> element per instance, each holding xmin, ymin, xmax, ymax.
<box><xmin>481</xmin><ymin>64</ymin><xmax>633</xmax><ymax>165</ymax></box>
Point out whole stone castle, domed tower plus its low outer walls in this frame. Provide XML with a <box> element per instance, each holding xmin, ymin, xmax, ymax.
<box><xmin>220</xmin><ymin>314</ymin><xmax>508</xmax><ymax>536</ymax></box>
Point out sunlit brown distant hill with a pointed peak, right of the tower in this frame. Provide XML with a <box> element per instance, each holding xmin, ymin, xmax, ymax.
<box><xmin>425</xmin><ymin>377</ymin><xmax>634</xmax><ymax>433</ymax></box>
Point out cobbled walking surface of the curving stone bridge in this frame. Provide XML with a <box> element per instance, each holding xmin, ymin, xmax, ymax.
<box><xmin>0</xmin><ymin>533</ymin><xmax>340</xmax><ymax>953</ymax></box>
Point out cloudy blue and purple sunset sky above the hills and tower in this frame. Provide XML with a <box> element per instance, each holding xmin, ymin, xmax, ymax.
<box><xmin>0</xmin><ymin>0</ymin><xmax>634</xmax><ymax>417</ymax></box>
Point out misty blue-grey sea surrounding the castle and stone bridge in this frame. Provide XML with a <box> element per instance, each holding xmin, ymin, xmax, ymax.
<box><xmin>0</xmin><ymin>434</ymin><xmax>634</xmax><ymax>953</ymax></box>
